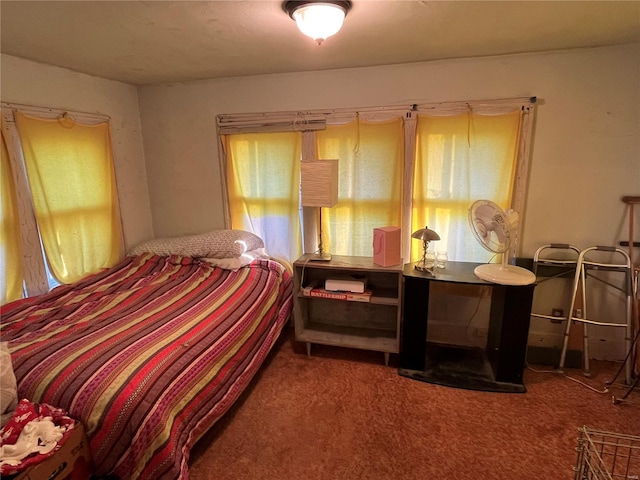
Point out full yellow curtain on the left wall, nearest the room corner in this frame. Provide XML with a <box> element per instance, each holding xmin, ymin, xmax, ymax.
<box><xmin>15</xmin><ymin>112</ymin><xmax>122</xmax><ymax>283</ymax></box>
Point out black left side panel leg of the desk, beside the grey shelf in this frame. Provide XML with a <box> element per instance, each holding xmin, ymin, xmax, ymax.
<box><xmin>400</xmin><ymin>277</ymin><xmax>431</xmax><ymax>372</ymax></box>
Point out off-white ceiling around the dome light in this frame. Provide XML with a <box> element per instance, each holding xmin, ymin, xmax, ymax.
<box><xmin>0</xmin><ymin>0</ymin><xmax>640</xmax><ymax>85</ymax></box>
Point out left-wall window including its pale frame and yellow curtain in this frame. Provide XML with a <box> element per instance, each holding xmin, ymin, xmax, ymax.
<box><xmin>2</xmin><ymin>104</ymin><xmax>123</xmax><ymax>302</ymax></box>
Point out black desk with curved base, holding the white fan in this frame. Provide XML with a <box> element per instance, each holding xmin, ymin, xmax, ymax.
<box><xmin>399</xmin><ymin>262</ymin><xmax>535</xmax><ymax>393</ymax></box>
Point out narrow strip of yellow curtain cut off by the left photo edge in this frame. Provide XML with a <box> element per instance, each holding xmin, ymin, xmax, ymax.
<box><xmin>0</xmin><ymin>124</ymin><xmax>24</xmax><ymax>305</ymax></box>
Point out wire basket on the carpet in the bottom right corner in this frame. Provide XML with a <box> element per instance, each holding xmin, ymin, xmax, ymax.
<box><xmin>574</xmin><ymin>427</ymin><xmax>640</xmax><ymax>480</ymax></box>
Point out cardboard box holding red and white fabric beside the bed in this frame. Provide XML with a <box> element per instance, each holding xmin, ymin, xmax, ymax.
<box><xmin>12</xmin><ymin>423</ymin><xmax>93</xmax><ymax>480</ymax></box>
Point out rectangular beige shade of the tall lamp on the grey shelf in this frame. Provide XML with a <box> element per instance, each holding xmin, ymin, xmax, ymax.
<box><xmin>300</xmin><ymin>160</ymin><xmax>338</xmax><ymax>207</ymax></box>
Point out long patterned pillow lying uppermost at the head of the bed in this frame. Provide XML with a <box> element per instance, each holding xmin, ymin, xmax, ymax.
<box><xmin>129</xmin><ymin>230</ymin><xmax>264</xmax><ymax>258</ymax></box>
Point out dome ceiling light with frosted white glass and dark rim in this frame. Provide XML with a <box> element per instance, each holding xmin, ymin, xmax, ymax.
<box><xmin>282</xmin><ymin>0</ymin><xmax>351</xmax><ymax>45</ymax></box>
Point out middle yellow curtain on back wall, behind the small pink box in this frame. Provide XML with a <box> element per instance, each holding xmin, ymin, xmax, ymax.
<box><xmin>316</xmin><ymin>118</ymin><xmax>404</xmax><ymax>257</ymax></box>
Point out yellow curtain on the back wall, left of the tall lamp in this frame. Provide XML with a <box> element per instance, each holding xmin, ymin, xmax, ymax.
<box><xmin>224</xmin><ymin>132</ymin><xmax>302</xmax><ymax>260</ymax></box>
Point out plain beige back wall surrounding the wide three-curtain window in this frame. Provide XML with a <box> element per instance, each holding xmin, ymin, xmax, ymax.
<box><xmin>139</xmin><ymin>45</ymin><xmax>640</xmax><ymax>357</ymax></box>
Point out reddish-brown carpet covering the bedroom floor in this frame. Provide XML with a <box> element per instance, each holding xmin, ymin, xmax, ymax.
<box><xmin>190</xmin><ymin>327</ymin><xmax>640</xmax><ymax>480</ymax></box>
